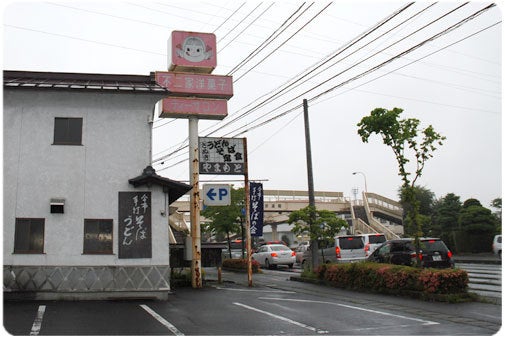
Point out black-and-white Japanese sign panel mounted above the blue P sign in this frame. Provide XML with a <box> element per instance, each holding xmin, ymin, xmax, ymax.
<box><xmin>198</xmin><ymin>137</ymin><xmax>245</xmax><ymax>175</ymax></box>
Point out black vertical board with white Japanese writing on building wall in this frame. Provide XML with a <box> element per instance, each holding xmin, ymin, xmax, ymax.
<box><xmin>118</xmin><ymin>191</ymin><xmax>152</xmax><ymax>258</ymax></box>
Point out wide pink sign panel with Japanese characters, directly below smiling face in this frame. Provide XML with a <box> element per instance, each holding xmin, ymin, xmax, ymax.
<box><xmin>155</xmin><ymin>72</ymin><xmax>233</xmax><ymax>99</ymax></box>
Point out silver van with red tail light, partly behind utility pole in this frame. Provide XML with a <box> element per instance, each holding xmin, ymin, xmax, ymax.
<box><xmin>302</xmin><ymin>235</ymin><xmax>366</xmax><ymax>268</ymax></box>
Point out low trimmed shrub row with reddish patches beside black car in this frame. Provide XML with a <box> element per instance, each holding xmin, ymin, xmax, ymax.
<box><xmin>316</xmin><ymin>262</ymin><xmax>468</xmax><ymax>295</ymax></box>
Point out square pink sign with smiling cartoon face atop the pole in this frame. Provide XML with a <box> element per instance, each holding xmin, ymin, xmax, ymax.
<box><xmin>168</xmin><ymin>31</ymin><xmax>217</xmax><ymax>74</ymax></box>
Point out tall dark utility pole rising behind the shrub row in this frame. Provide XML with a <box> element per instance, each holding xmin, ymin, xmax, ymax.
<box><xmin>303</xmin><ymin>99</ymin><xmax>319</xmax><ymax>269</ymax></box>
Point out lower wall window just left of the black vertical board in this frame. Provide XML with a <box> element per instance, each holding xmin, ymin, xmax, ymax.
<box><xmin>83</xmin><ymin>219</ymin><xmax>112</xmax><ymax>254</ymax></box>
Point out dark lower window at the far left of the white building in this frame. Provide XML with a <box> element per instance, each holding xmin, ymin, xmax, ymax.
<box><xmin>14</xmin><ymin>218</ymin><xmax>44</xmax><ymax>254</ymax></box>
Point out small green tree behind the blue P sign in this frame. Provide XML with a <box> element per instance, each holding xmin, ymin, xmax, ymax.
<box><xmin>201</xmin><ymin>188</ymin><xmax>245</xmax><ymax>257</ymax></box>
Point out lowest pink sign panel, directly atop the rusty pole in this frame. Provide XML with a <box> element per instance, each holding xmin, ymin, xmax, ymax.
<box><xmin>160</xmin><ymin>97</ymin><xmax>228</xmax><ymax>120</ymax></box>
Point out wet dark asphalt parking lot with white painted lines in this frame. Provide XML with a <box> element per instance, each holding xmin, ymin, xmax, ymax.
<box><xmin>3</xmin><ymin>268</ymin><xmax>501</xmax><ymax>336</ymax></box>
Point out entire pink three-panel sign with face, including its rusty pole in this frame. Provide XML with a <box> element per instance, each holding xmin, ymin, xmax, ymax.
<box><xmin>153</xmin><ymin>31</ymin><xmax>233</xmax><ymax>288</ymax></box>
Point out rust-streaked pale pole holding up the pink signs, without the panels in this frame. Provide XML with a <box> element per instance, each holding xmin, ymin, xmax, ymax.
<box><xmin>189</xmin><ymin>117</ymin><xmax>202</xmax><ymax>289</ymax></box>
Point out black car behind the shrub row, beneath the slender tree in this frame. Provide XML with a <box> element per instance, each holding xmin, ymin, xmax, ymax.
<box><xmin>367</xmin><ymin>238</ymin><xmax>454</xmax><ymax>268</ymax></box>
